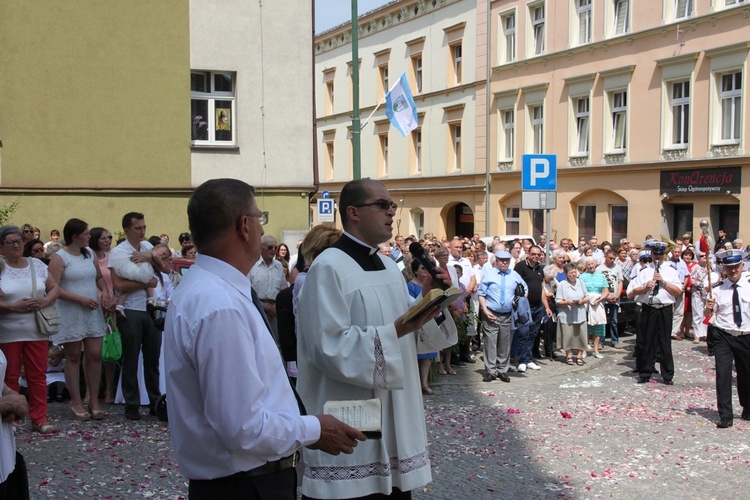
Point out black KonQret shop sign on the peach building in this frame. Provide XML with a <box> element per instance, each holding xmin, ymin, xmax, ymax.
<box><xmin>659</xmin><ymin>167</ymin><xmax>742</xmax><ymax>195</ymax></box>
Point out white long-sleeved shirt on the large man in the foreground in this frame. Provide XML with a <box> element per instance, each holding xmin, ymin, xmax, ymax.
<box><xmin>164</xmin><ymin>255</ymin><xmax>320</xmax><ymax>479</ymax></box>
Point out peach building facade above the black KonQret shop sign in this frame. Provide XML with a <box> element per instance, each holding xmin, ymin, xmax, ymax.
<box><xmin>489</xmin><ymin>0</ymin><xmax>750</xmax><ymax>246</ymax></box>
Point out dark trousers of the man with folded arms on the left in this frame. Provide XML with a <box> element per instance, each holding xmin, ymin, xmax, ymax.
<box><xmin>117</xmin><ymin>309</ymin><xmax>161</xmax><ymax>408</ymax></box>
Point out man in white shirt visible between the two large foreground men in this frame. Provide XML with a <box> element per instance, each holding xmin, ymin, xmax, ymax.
<box><xmin>250</xmin><ymin>234</ymin><xmax>289</xmax><ymax>343</ymax></box>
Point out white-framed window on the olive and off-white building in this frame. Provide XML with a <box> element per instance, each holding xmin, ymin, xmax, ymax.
<box><xmin>190</xmin><ymin>70</ymin><xmax>237</xmax><ymax>147</ymax></box>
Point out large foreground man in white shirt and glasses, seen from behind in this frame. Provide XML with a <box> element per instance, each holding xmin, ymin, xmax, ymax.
<box><xmin>164</xmin><ymin>179</ymin><xmax>366</xmax><ymax>500</ymax></box>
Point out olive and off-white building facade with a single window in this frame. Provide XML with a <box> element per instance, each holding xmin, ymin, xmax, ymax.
<box><xmin>0</xmin><ymin>0</ymin><xmax>314</xmax><ymax>239</ymax></box>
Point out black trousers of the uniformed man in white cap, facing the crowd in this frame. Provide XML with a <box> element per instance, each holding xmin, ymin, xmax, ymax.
<box><xmin>635</xmin><ymin>304</ymin><xmax>674</xmax><ymax>382</ymax></box>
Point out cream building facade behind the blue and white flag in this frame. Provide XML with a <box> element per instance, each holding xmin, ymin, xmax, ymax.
<box><xmin>315</xmin><ymin>0</ymin><xmax>485</xmax><ymax>239</ymax></box>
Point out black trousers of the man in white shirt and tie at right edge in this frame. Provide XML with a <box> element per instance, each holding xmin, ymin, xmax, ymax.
<box><xmin>714</xmin><ymin>328</ymin><xmax>750</xmax><ymax>420</ymax></box>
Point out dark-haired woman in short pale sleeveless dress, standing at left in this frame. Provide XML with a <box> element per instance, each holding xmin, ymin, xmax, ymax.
<box><xmin>49</xmin><ymin>219</ymin><xmax>113</xmax><ymax>420</ymax></box>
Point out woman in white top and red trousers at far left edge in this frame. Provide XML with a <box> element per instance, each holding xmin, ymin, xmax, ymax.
<box><xmin>0</xmin><ymin>226</ymin><xmax>60</xmax><ymax>434</ymax></box>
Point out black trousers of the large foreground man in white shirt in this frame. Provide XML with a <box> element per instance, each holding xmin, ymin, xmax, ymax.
<box><xmin>188</xmin><ymin>467</ymin><xmax>297</xmax><ymax>500</ymax></box>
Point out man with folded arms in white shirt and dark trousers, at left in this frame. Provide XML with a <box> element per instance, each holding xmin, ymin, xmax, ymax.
<box><xmin>109</xmin><ymin>212</ymin><xmax>161</xmax><ymax>420</ymax></box>
